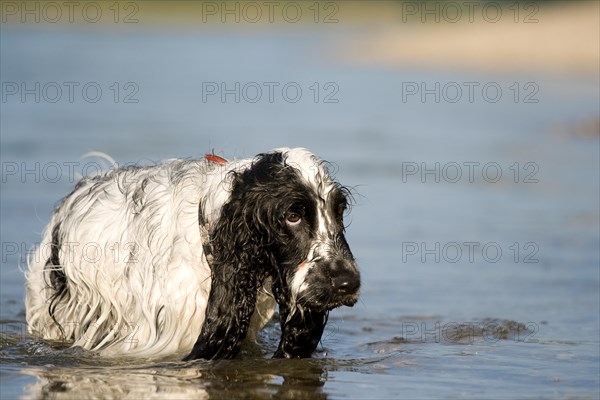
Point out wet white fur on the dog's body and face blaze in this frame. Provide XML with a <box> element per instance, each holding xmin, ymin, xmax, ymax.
<box><xmin>26</xmin><ymin>149</ymin><xmax>330</xmax><ymax>357</ymax></box>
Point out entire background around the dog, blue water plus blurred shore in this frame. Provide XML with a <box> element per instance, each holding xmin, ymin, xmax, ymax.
<box><xmin>0</xmin><ymin>1</ymin><xmax>600</xmax><ymax>398</ymax></box>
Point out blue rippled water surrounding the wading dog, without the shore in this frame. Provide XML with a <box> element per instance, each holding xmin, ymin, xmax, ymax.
<box><xmin>0</xmin><ymin>18</ymin><xmax>600</xmax><ymax>399</ymax></box>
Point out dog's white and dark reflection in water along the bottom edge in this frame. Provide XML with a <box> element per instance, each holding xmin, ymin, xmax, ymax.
<box><xmin>19</xmin><ymin>359</ymin><xmax>327</xmax><ymax>399</ymax></box>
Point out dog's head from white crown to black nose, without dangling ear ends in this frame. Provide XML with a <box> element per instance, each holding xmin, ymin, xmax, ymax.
<box><xmin>222</xmin><ymin>149</ymin><xmax>360</xmax><ymax>311</ymax></box>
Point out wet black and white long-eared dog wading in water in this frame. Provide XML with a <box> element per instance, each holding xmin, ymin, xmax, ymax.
<box><xmin>26</xmin><ymin>148</ymin><xmax>360</xmax><ymax>360</ymax></box>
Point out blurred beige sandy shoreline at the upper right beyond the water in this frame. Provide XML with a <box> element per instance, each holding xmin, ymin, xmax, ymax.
<box><xmin>338</xmin><ymin>1</ymin><xmax>600</xmax><ymax>79</ymax></box>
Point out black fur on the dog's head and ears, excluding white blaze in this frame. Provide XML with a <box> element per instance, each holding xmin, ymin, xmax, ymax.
<box><xmin>184</xmin><ymin>153</ymin><xmax>351</xmax><ymax>360</ymax></box>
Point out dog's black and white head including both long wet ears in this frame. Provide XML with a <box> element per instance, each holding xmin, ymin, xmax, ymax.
<box><xmin>185</xmin><ymin>149</ymin><xmax>360</xmax><ymax>358</ymax></box>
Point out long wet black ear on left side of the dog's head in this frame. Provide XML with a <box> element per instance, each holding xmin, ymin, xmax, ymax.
<box><xmin>184</xmin><ymin>157</ymin><xmax>281</xmax><ymax>361</ymax></box>
